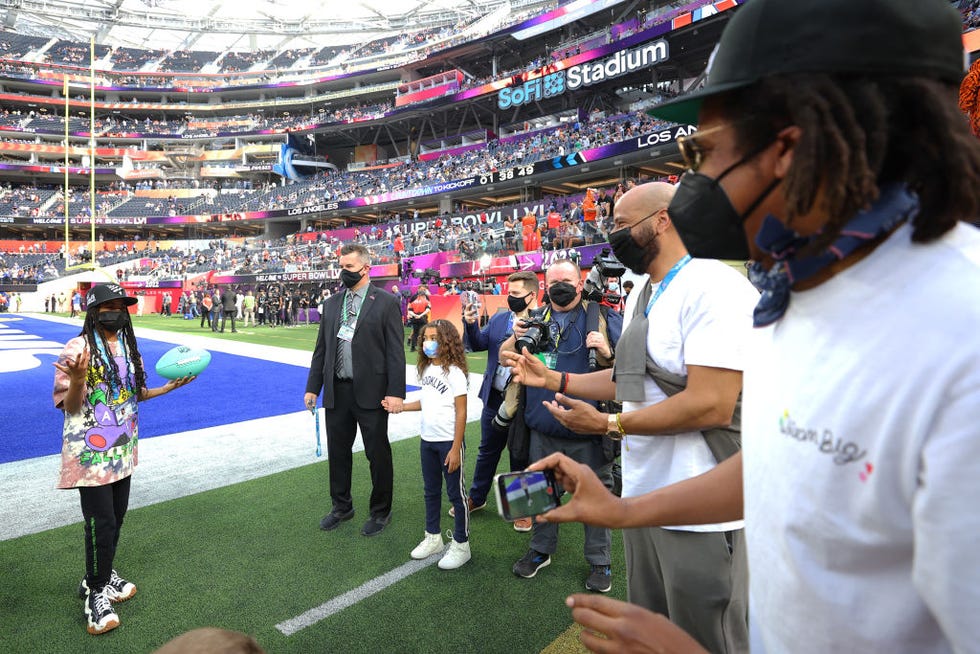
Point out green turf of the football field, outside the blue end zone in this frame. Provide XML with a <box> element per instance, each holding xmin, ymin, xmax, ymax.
<box><xmin>0</xmin><ymin>316</ymin><xmax>625</xmax><ymax>653</ymax></box>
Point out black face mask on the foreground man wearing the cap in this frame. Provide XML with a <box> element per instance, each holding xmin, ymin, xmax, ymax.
<box><xmin>668</xmin><ymin>146</ymin><xmax>782</xmax><ymax>263</ymax></box>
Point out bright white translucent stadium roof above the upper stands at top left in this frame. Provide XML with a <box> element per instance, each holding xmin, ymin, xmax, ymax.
<box><xmin>0</xmin><ymin>0</ymin><xmax>506</xmax><ymax>52</ymax></box>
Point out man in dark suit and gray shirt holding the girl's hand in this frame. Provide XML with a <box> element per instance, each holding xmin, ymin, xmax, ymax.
<box><xmin>304</xmin><ymin>243</ymin><xmax>405</xmax><ymax>536</ymax></box>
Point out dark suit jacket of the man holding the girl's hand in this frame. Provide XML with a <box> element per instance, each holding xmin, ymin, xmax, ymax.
<box><xmin>306</xmin><ymin>284</ymin><xmax>405</xmax><ymax>409</ymax></box>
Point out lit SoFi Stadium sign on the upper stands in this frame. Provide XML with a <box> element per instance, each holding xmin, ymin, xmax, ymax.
<box><xmin>497</xmin><ymin>39</ymin><xmax>670</xmax><ymax>109</ymax></box>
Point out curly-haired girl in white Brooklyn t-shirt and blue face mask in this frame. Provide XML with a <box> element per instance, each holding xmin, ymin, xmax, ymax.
<box><xmin>382</xmin><ymin>320</ymin><xmax>470</xmax><ymax>570</ymax></box>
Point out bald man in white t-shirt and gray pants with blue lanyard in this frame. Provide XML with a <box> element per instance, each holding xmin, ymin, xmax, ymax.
<box><xmin>508</xmin><ymin>183</ymin><xmax>759</xmax><ymax>652</ymax></box>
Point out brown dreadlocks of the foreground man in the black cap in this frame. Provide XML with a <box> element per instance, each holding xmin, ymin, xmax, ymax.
<box><xmin>724</xmin><ymin>74</ymin><xmax>980</xmax><ymax>253</ymax></box>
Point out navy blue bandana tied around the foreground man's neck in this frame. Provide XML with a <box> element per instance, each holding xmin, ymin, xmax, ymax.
<box><xmin>749</xmin><ymin>184</ymin><xmax>919</xmax><ymax>327</ymax></box>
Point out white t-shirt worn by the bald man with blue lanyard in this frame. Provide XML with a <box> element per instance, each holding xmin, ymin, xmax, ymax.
<box><xmin>622</xmin><ymin>259</ymin><xmax>759</xmax><ymax>532</ymax></box>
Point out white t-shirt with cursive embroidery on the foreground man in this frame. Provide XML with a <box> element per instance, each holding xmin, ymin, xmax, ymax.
<box><xmin>742</xmin><ymin>224</ymin><xmax>980</xmax><ymax>654</ymax></box>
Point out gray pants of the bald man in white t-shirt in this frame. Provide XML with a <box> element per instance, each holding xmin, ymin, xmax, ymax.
<box><xmin>623</xmin><ymin>527</ymin><xmax>749</xmax><ymax>654</ymax></box>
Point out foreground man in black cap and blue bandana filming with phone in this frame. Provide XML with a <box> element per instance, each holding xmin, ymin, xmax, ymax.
<box><xmin>520</xmin><ymin>0</ymin><xmax>980</xmax><ymax>652</ymax></box>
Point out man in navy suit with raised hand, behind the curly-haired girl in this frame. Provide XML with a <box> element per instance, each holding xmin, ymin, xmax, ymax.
<box><xmin>463</xmin><ymin>270</ymin><xmax>538</xmax><ymax>531</ymax></box>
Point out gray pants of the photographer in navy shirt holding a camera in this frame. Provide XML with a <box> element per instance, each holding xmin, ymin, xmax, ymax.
<box><xmin>529</xmin><ymin>429</ymin><xmax>612</xmax><ymax>565</ymax></box>
